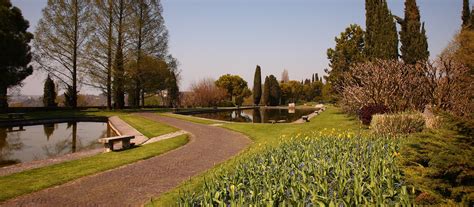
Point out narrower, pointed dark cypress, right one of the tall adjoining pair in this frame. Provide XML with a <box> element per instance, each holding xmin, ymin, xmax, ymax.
<box><xmin>400</xmin><ymin>0</ymin><xmax>430</xmax><ymax>64</ymax></box>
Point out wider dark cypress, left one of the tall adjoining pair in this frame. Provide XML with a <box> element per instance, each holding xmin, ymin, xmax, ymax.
<box><xmin>365</xmin><ymin>0</ymin><xmax>398</xmax><ymax>60</ymax></box>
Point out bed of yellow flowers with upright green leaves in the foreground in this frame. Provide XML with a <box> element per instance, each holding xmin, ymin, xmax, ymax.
<box><xmin>179</xmin><ymin>131</ymin><xmax>410</xmax><ymax>206</ymax></box>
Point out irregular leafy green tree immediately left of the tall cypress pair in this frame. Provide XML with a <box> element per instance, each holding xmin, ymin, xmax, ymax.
<box><xmin>326</xmin><ymin>24</ymin><xmax>366</xmax><ymax>94</ymax></box>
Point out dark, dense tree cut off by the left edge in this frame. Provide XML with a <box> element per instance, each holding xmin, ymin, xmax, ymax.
<box><xmin>0</xmin><ymin>0</ymin><xmax>33</xmax><ymax>109</ymax></box>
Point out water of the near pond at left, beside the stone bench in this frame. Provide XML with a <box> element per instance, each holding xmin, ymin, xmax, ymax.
<box><xmin>0</xmin><ymin>122</ymin><xmax>115</xmax><ymax>167</ymax></box>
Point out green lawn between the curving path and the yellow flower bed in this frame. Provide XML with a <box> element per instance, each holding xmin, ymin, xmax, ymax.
<box><xmin>147</xmin><ymin>107</ymin><xmax>368</xmax><ymax>206</ymax></box>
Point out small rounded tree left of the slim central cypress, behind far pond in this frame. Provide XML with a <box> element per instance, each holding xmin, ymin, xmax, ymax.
<box><xmin>216</xmin><ymin>74</ymin><xmax>248</xmax><ymax>101</ymax></box>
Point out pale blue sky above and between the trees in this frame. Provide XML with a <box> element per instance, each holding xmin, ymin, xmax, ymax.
<box><xmin>12</xmin><ymin>0</ymin><xmax>462</xmax><ymax>95</ymax></box>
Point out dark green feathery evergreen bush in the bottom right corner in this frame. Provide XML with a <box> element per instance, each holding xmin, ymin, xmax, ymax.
<box><xmin>400</xmin><ymin>114</ymin><xmax>474</xmax><ymax>206</ymax></box>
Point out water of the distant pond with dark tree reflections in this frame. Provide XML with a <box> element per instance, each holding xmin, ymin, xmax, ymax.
<box><xmin>193</xmin><ymin>108</ymin><xmax>315</xmax><ymax>123</ymax></box>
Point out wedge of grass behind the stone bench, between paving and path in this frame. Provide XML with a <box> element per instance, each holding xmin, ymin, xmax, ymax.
<box><xmin>120</xmin><ymin>114</ymin><xmax>179</xmax><ymax>138</ymax></box>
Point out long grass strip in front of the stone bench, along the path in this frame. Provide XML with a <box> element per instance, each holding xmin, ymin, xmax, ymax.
<box><xmin>0</xmin><ymin>135</ymin><xmax>188</xmax><ymax>201</ymax></box>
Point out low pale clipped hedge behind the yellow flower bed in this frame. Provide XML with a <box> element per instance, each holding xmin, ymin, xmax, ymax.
<box><xmin>370</xmin><ymin>113</ymin><xmax>425</xmax><ymax>134</ymax></box>
